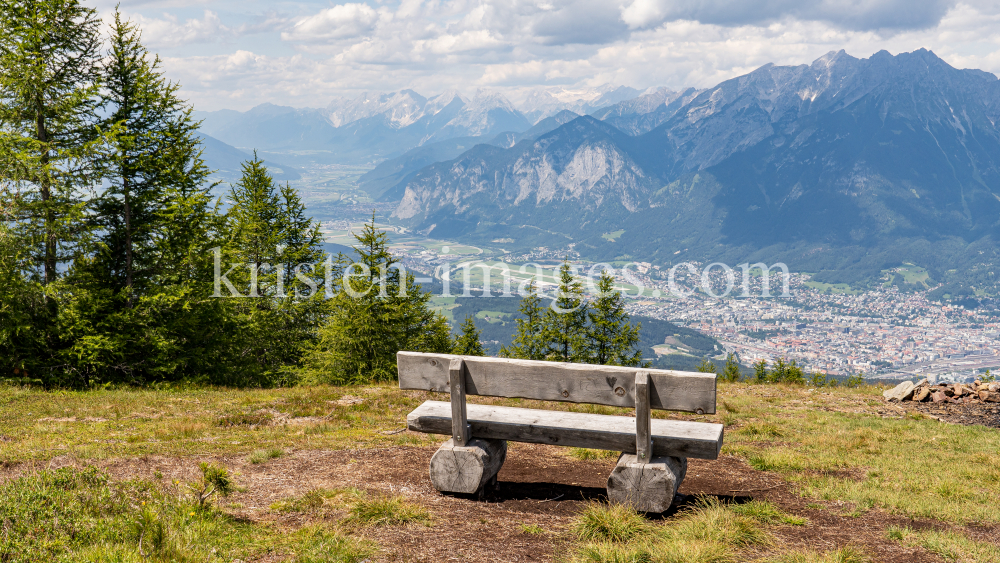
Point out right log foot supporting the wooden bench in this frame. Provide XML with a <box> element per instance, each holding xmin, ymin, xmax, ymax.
<box><xmin>608</xmin><ymin>454</ymin><xmax>687</xmax><ymax>512</ymax></box>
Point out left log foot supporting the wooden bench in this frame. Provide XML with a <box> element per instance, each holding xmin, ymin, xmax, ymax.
<box><xmin>430</xmin><ymin>438</ymin><xmax>507</xmax><ymax>495</ymax></box>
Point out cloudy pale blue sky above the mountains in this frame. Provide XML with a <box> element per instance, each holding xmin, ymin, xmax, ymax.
<box><xmin>95</xmin><ymin>0</ymin><xmax>1000</xmax><ymax>111</ymax></box>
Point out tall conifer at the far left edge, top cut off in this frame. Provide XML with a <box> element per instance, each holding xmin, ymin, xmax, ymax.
<box><xmin>0</xmin><ymin>0</ymin><xmax>102</xmax><ymax>285</ymax></box>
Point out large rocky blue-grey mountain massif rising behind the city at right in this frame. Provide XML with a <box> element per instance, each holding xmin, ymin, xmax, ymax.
<box><xmin>382</xmin><ymin>49</ymin><xmax>1000</xmax><ymax>291</ymax></box>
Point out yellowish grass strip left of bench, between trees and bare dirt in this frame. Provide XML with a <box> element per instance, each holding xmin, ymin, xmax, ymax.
<box><xmin>0</xmin><ymin>385</ymin><xmax>439</xmax><ymax>463</ymax></box>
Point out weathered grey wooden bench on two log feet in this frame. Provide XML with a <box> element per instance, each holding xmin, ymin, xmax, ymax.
<box><xmin>396</xmin><ymin>352</ymin><xmax>723</xmax><ymax>512</ymax></box>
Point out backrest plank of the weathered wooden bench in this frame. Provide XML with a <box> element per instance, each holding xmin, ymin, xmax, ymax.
<box><xmin>396</xmin><ymin>352</ymin><xmax>716</xmax><ymax>414</ymax></box>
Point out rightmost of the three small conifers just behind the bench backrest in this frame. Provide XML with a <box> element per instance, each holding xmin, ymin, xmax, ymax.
<box><xmin>586</xmin><ymin>272</ymin><xmax>642</xmax><ymax>366</ymax></box>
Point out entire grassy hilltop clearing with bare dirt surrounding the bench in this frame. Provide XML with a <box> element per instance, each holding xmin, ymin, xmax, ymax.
<box><xmin>0</xmin><ymin>383</ymin><xmax>1000</xmax><ymax>563</ymax></box>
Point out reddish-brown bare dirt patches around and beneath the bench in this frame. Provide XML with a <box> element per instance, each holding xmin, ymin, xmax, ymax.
<box><xmin>21</xmin><ymin>443</ymin><xmax>984</xmax><ymax>563</ymax></box>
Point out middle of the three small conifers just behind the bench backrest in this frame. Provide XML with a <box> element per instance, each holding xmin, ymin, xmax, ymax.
<box><xmin>542</xmin><ymin>262</ymin><xmax>590</xmax><ymax>362</ymax></box>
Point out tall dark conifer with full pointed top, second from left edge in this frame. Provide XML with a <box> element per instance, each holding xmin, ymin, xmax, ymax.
<box><xmin>97</xmin><ymin>9</ymin><xmax>208</xmax><ymax>300</ymax></box>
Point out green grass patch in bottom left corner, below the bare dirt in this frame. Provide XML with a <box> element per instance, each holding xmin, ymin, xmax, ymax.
<box><xmin>0</xmin><ymin>468</ymin><xmax>266</xmax><ymax>563</ymax></box>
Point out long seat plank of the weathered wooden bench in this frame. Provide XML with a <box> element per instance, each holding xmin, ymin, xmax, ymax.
<box><xmin>406</xmin><ymin>401</ymin><xmax>723</xmax><ymax>459</ymax></box>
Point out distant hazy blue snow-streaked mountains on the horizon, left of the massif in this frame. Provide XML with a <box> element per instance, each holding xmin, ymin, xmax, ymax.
<box><xmin>196</xmin><ymin>85</ymin><xmax>675</xmax><ymax>165</ymax></box>
